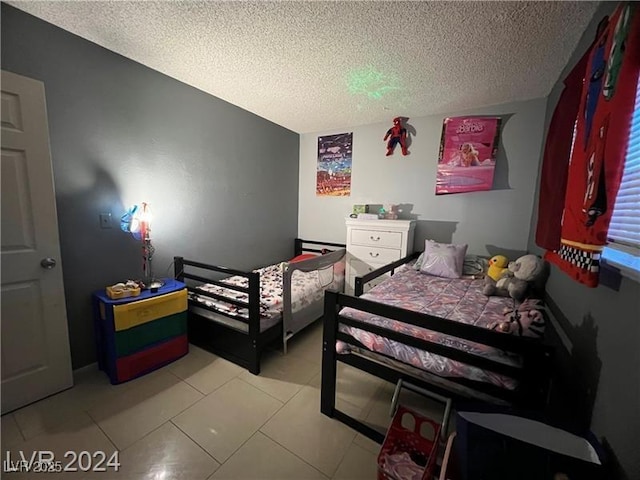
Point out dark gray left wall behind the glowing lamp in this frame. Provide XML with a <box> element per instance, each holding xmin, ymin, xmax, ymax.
<box><xmin>2</xmin><ymin>4</ymin><xmax>299</xmax><ymax>368</ymax></box>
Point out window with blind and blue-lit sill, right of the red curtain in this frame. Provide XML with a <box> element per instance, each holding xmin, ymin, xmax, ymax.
<box><xmin>602</xmin><ymin>81</ymin><xmax>640</xmax><ymax>281</ymax></box>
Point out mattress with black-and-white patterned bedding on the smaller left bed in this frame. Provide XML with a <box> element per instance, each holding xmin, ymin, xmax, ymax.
<box><xmin>190</xmin><ymin>262</ymin><xmax>344</xmax><ymax>331</ymax></box>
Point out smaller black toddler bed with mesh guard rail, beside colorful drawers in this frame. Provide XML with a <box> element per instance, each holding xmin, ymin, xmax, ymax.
<box><xmin>175</xmin><ymin>239</ymin><xmax>346</xmax><ymax>374</ymax></box>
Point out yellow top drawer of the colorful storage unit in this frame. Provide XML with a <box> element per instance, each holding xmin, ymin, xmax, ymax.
<box><xmin>113</xmin><ymin>289</ymin><xmax>187</xmax><ymax>331</ymax></box>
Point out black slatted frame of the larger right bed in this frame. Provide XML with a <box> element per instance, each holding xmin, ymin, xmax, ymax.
<box><xmin>320</xmin><ymin>253</ymin><xmax>554</xmax><ymax>443</ymax></box>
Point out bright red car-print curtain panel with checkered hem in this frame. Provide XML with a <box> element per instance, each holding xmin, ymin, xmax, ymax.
<box><xmin>545</xmin><ymin>2</ymin><xmax>640</xmax><ymax>287</ymax></box>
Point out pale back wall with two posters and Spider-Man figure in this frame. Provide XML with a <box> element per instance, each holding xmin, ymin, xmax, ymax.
<box><xmin>298</xmin><ymin>98</ymin><xmax>546</xmax><ymax>254</ymax></box>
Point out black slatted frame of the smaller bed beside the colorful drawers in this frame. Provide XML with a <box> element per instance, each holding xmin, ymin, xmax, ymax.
<box><xmin>173</xmin><ymin>238</ymin><xmax>344</xmax><ymax>375</ymax></box>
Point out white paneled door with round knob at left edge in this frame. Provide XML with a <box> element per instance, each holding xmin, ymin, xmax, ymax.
<box><xmin>0</xmin><ymin>71</ymin><xmax>73</xmax><ymax>413</ymax></box>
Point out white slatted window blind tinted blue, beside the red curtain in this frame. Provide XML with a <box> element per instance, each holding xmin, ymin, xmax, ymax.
<box><xmin>609</xmin><ymin>82</ymin><xmax>640</xmax><ymax>251</ymax></box>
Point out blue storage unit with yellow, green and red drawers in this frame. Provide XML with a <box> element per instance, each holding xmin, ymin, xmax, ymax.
<box><xmin>93</xmin><ymin>279</ymin><xmax>189</xmax><ymax>384</ymax></box>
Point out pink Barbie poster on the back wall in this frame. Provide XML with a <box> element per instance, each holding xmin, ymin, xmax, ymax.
<box><xmin>436</xmin><ymin>117</ymin><xmax>500</xmax><ymax>195</ymax></box>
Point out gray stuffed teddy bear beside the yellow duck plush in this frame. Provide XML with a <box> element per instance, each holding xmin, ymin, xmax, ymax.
<box><xmin>483</xmin><ymin>255</ymin><xmax>546</xmax><ymax>301</ymax></box>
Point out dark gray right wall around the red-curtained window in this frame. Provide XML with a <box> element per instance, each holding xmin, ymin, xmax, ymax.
<box><xmin>529</xmin><ymin>2</ymin><xmax>640</xmax><ymax>479</ymax></box>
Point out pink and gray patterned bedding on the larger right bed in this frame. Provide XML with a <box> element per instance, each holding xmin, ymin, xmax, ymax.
<box><xmin>337</xmin><ymin>267</ymin><xmax>519</xmax><ymax>389</ymax></box>
